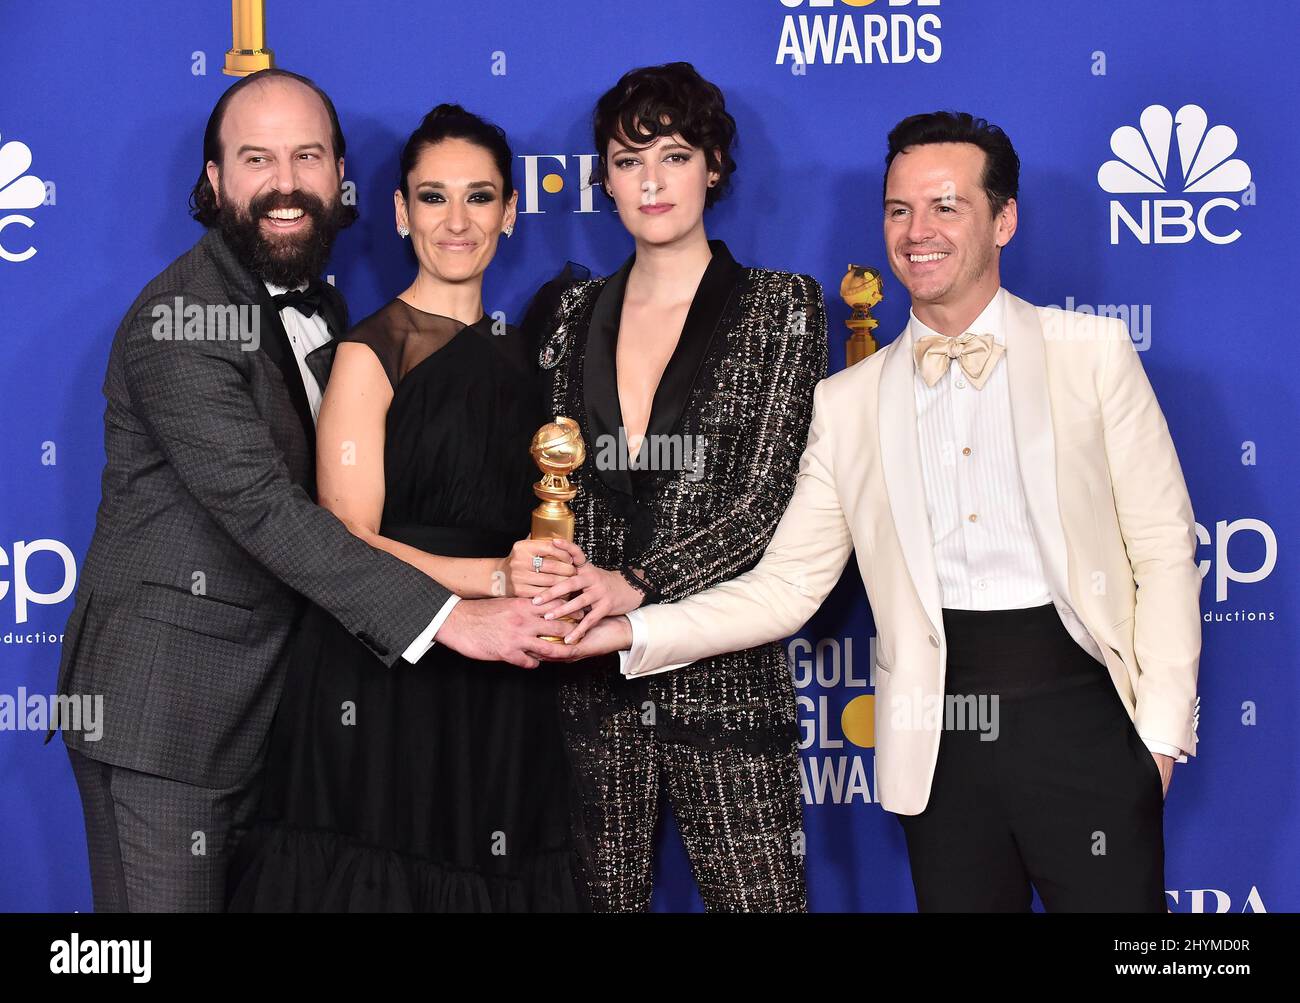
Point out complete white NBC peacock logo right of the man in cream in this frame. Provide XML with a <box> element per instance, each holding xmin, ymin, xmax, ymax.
<box><xmin>1097</xmin><ymin>104</ymin><xmax>1255</xmax><ymax>244</ymax></box>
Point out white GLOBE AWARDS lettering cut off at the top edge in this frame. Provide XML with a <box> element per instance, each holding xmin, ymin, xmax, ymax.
<box><xmin>776</xmin><ymin>0</ymin><xmax>944</xmax><ymax>68</ymax></box>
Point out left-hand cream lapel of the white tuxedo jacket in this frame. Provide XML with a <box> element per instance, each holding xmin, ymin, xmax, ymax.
<box><xmin>876</xmin><ymin>325</ymin><xmax>944</xmax><ymax>637</ymax></box>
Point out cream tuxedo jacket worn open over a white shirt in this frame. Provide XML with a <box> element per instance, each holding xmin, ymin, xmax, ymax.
<box><xmin>624</xmin><ymin>295</ymin><xmax>1201</xmax><ymax>815</ymax></box>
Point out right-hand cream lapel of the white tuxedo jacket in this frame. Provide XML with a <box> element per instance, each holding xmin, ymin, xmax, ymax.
<box><xmin>1005</xmin><ymin>292</ymin><xmax>1070</xmax><ymax>600</ymax></box>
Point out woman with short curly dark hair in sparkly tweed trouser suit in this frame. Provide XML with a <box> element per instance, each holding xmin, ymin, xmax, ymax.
<box><xmin>524</xmin><ymin>62</ymin><xmax>827</xmax><ymax>911</ymax></box>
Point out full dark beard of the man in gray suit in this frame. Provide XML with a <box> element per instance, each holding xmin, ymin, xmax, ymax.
<box><xmin>217</xmin><ymin>190</ymin><xmax>355</xmax><ymax>288</ymax></box>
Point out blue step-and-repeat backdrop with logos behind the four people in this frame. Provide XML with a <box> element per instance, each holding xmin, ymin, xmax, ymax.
<box><xmin>0</xmin><ymin>0</ymin><xmax>1300</xmax><ymax>912</ymax></box>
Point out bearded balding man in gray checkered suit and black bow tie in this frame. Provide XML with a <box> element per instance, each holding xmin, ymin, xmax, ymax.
<box><xmin>46</xmin><ymin>70</ymin><xmax>566</xmax><ymax>912</ymax></box>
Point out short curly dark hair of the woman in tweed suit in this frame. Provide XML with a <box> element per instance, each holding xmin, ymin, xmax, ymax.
<box><xmin>590</xmin><ymin>62</ymin><xmax>736</xmax><ymax>209</ymax></box>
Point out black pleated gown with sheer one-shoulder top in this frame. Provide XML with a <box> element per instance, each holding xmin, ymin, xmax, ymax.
<box><xmin>229</xmin><ymin>300</ymin><xmax>581</xmax><ymax>912</ymax></box>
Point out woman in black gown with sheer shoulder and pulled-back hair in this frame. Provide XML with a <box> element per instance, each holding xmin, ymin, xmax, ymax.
<box><xmin>229</xmin><ymin>105</ymin><xmax>581</xmax><ymax>912</ymax></box>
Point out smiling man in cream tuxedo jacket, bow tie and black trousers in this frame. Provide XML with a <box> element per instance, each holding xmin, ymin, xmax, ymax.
<box><xmin>542</xmin><ymin>113</ymin><xmax>1200</xmax><ymax>912</ymax></box>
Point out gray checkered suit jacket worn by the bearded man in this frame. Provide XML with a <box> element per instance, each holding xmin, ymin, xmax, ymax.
<box><xmin>47</xmin><ymin>230</ymin><xmax>450</xmax><ymax>787</ymax></box>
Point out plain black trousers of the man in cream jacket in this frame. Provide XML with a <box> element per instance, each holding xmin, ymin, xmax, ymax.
<box><xmin>898</xmin><ymin>605</ymin><xmax>1165</xmax><ymax>912</ymax></box>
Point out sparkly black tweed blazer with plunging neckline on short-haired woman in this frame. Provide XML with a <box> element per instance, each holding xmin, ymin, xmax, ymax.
<box><xmin>525</xmin><ymin>240</ymin><xmax>827</xmax><ymax>748</ymax></box>
